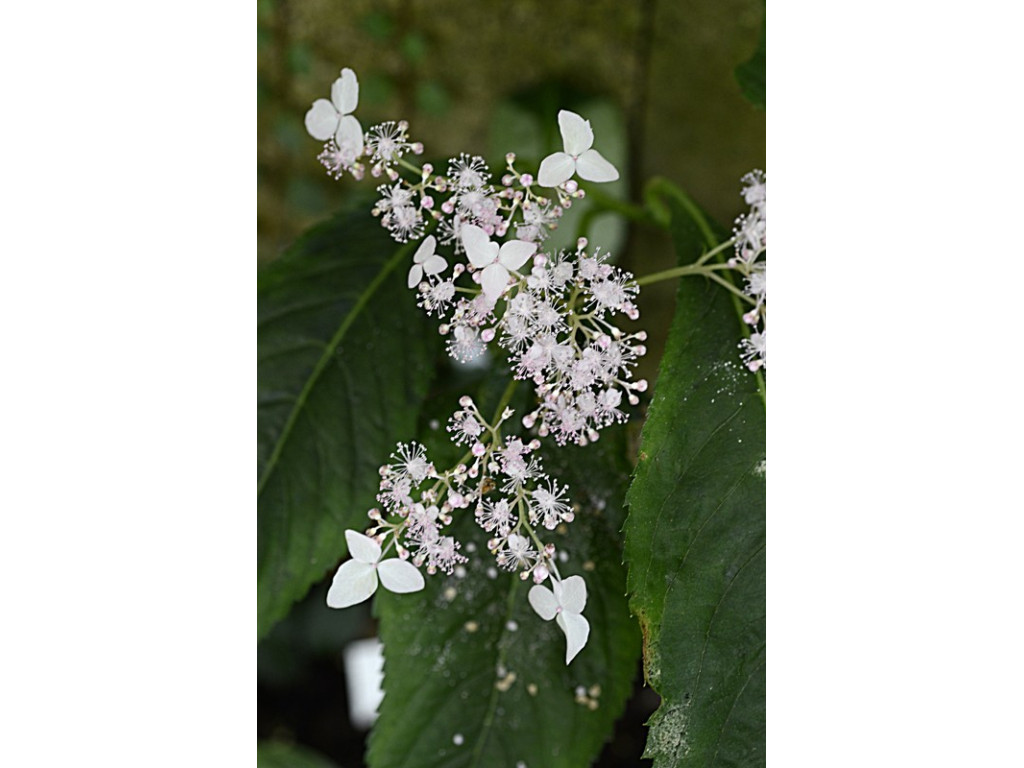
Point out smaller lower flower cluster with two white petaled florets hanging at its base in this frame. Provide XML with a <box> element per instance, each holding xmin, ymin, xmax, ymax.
<box><xmin>328</xmin><ymin>395</ymin><xmax>590</xmax><ymax>664</ymax></box>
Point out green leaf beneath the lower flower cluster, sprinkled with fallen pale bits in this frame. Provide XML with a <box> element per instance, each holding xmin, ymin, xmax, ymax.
<box><xmin>369</xmin><ymin>421</ymin><xmax>639</xmax><ymax>768</ymax></box>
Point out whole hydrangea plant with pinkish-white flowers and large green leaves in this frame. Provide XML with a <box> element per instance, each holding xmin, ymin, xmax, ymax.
<box><xmin>259</xmin><ymin>49</ymin><xmax>767</xmax><ymax>765</ymax></box>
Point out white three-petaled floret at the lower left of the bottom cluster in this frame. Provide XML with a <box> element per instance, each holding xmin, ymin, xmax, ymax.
<box><xmin>327</xmin><ymin>530</ymin><xmax>424</xmax><ymax>608</ymax></box>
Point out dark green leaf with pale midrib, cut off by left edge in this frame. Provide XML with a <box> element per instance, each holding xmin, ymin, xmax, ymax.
<box><xmin>257</xmin><ymin>202</ymin><xmax>436</xmax><ymax>637</ymax></box>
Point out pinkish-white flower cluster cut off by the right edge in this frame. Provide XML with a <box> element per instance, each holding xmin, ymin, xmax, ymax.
<box><xmin>730</xmin><ymin>171</ymin><xmax>768</xmax><ymax>372</ymax></box>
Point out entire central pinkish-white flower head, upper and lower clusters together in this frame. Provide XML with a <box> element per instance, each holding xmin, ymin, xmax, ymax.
<box><xmin>305</xmin><ymin>69</ymin><xmax>630</xmax><ymax>664</ymax></box>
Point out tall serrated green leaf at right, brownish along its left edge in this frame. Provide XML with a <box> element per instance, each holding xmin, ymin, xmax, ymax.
<box><xmin>625</xmin><ymin>193</ymin><xmax>765</xmax><ymax>768</ymax></box>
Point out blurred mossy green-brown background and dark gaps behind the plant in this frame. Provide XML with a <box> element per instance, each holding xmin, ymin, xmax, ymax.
<box><xmin>257</xmin><ymin>0</ymin><xmax>765</xmax><ymax>766</ymax></box>
